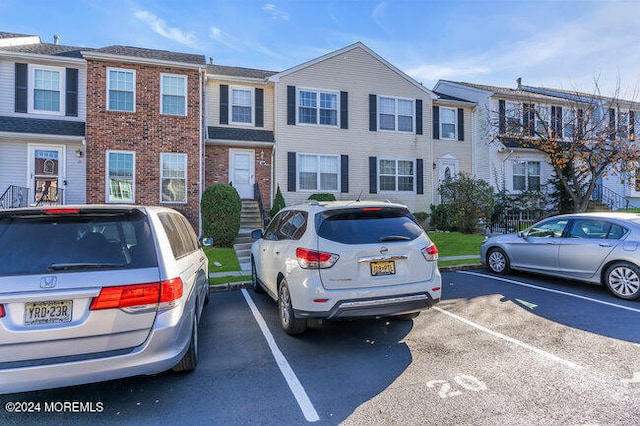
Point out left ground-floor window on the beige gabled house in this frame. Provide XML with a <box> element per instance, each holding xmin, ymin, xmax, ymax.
<box><xmin>297</xmin><ymin>154</ymin><xmax>340</xmax><ymax>192</ymax></box>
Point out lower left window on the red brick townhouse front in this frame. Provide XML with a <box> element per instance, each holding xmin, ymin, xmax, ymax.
<box><xmin>106</xmin><ymin>151</ymin><xmax>135</xmax><ymax>203</ymax></box>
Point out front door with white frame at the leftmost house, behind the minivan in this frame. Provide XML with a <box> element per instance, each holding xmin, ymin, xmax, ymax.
<box><xmin>29</xmin><ymin>145</ymin><xmax>65</xmax><ymax>204</ymax></box>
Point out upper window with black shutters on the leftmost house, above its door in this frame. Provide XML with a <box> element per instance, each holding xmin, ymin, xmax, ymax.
<box><xmin>29</xmin><ymin>66</ymin><xmax>65</xmax><ymax>114</ymax></box>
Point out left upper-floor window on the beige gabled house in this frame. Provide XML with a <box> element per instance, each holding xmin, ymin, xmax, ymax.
<box><xmin>298</xmin><ymin>89</ymin><xmax>338</xmax><ymax>126</ymax></box>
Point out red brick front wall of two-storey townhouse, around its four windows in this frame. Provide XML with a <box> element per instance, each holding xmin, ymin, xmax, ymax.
<box><xmin>86</xmin><ymin>60</ymin><xmax>204</xmax><ymax>232</ymax></box>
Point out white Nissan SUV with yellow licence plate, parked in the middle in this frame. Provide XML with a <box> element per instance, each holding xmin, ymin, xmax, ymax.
<box><xmin>251</xmin><ymin>201</ymin><xmax>441</xmax><ymax>335</ymax></box>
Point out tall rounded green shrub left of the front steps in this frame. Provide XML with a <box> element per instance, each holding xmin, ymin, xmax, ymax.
<box><xmin>200</xmin><ymin>184</ymin><xmax>242</xmax><ymax>247</ymax></box>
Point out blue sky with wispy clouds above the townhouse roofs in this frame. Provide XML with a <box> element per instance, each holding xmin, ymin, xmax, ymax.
<box><xmin>0</xmin><ymin>0</ymin><xmax>640</xmax><ymax>100</ymax></box>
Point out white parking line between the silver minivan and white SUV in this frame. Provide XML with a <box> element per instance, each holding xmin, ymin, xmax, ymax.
<box><xmin>242</xmin><ymin>289</ymin><xmax>320</xmax><ymax>422</ymax></box>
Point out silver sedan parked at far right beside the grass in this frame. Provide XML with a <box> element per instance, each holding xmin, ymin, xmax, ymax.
<box><xmin>480</xmin><ymin>213</ymin><xmax>640</xmax><ymax>300</ymax></box>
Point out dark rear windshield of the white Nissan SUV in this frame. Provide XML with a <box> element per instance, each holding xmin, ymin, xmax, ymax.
<box><xmin>316</xmin><ymin>208</ymin><xmax>423</xmax><ymax>244</ymax></box>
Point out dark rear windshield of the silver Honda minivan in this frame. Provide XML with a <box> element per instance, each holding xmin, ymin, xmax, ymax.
<box><xmin>0</xmin><ymin>211</ymin><xmax>158</xmax><ymax>276</ymax></box>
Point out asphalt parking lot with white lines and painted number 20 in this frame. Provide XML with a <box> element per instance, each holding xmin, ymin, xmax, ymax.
<box><xmin>0</xmin><ymin>270</ymin><xmax>640</xmax><ymax>425</ymax></box>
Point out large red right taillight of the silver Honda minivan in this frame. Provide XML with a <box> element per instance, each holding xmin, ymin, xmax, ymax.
<box><xmin>91</xmin><ymin>278</ymin><xmax>182</xmax><ymax>310</ymax></box>
